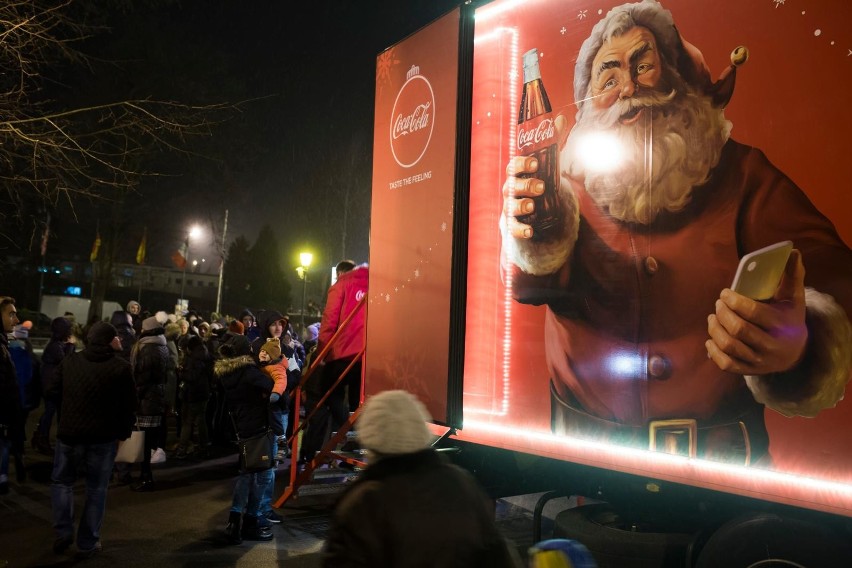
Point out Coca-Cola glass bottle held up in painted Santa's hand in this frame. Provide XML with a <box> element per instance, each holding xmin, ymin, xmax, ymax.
<box><xmin>517</xmin><ymin>49</ymin><xmax>565</xmax><ymax>241</ymax></box>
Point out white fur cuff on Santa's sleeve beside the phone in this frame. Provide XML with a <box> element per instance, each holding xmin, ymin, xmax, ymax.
<box><xmin>745</xmin><ymin>288</ymin><xmax>852</xmax><ymax>417</ymax></box>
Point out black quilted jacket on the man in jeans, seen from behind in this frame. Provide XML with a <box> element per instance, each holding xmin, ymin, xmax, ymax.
<box><xmin>51</xmin><ymin>345</ymin><xmax>136</xmax><ymax>444</ymax></box>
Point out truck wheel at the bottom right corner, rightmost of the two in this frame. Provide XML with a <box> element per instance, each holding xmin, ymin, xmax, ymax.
<box><xmin>695</xmin><ymin>513</ymin><xmax>850</xmax><ymax>568</ymax></box>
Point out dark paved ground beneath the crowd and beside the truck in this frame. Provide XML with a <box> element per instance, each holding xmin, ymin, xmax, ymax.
<box><xmin>0</xmin><ymin>432</ymin><xmax>556</xmax><ymax>568</ymax></box>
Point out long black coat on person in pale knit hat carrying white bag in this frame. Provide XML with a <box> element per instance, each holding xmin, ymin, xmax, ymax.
<box><xmin>131</xmin><ymin>328</ymin><xmax>169</xmax><ymax>416</ymax></box>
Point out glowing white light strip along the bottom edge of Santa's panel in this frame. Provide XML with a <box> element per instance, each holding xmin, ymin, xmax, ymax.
<box><xmin>458</xmin><ymin>418</ymin><xmax>852</xmax><ymax>516</ymax></box>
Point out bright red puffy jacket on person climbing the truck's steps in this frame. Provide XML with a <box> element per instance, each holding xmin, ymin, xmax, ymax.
<box><xmin>317</xmin><ymin>264</ymin><xmax>370</xmax><ymax>361</ymax></box>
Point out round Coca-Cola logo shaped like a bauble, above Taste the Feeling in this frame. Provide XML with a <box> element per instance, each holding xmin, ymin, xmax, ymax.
<box><xmin>390</xmin><ymin>66</ymin><xmax>435</xmax><ymax>168</ymax></box>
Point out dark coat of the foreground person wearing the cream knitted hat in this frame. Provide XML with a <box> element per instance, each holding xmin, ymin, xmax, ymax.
<box><xmin>323</xmin><ymin>449</ymin><xmax>518</xmax><ymax>568</ymax></box>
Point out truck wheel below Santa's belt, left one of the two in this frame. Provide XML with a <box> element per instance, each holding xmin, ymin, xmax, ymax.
<box><xmin>553</xmin><ymin>503</ymin><xmax>694</xmax><ymax>568</ymax></box>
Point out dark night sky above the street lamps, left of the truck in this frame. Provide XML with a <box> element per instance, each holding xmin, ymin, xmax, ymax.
<box><xmin>41</xmin><ymin>0</ymin><xmax>461</xmax><ymax>272</ymax></box>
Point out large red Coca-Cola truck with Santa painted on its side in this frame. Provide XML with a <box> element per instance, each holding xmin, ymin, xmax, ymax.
<box><xmin>364</xmin><ymin>0</ymin><xmax>852</xmax><ymax>566</ymax></box>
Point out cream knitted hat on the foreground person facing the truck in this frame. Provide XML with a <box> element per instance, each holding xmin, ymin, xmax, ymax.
<box><xmin>355</xmin><ymin>390</ymin><xmax>432</xmax><ymax>455</ymax></box>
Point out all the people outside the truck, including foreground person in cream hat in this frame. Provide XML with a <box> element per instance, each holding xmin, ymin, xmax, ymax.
<box><xmin>0</xmin><ymin>274</ymin><xmax>593</xmax><ymax>568</ymax></box>
